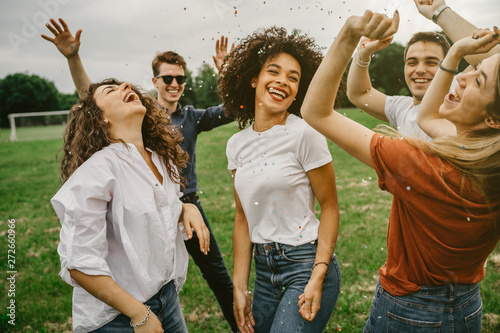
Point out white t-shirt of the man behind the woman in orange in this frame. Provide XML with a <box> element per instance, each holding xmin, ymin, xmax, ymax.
<box><xmin>384</xmin><ymin>96</ymin><xmax>432</xmax><ymax>141</ymax></box>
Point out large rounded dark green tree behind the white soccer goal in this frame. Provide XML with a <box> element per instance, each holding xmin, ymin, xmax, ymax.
<box><xmin>0</xmin><ymin>73</ymin><xmax>59</xmax><ymax>127</ymax></box>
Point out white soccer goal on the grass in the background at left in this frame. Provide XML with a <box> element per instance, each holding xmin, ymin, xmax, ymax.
<box><xmin>8</xmin><ymin>110</ymin><xmax>69</xmax><ymax>141</ymax></box>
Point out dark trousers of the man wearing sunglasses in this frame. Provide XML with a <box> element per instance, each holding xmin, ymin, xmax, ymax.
<box><xmin>181</xmin><ymin>195</ymin><xmax>238</xmax><ymax>332</ymax></box>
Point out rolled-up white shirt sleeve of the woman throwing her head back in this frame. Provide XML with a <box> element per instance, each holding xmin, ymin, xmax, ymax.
<box><xmin>51</xmin><ymin>163</ymin><xmax>115</xmax><ymax>286</ymax></box>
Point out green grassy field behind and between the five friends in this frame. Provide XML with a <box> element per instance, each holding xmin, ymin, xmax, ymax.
<box><xmin>0</xmin><ymin>110</ymin><xmax>500</xmax><ymax>333</ymax></box>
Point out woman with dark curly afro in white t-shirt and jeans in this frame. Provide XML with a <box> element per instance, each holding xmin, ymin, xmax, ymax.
<box><xmin>218</xmin><ymin>27</ymin><xmax>340</xmax><ymax>332</ymax></box>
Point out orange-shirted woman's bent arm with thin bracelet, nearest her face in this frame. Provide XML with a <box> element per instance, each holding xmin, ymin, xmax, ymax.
<box><xmin>417</xmin><ymin>31</ymin><xmax>500</xmax><ymax>138</ymax></box>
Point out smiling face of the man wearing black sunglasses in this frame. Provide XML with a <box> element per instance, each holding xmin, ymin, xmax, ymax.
<box><xmin>153</xmin><ymin>62</ymin><xmax>185</xmax><ymax>107</ymax></box>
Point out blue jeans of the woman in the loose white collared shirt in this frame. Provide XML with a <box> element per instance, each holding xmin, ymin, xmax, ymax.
<box><xmin>93</xmin><ymin>281</ymin><xmax>187</xmax><ymax>333</ymax></box>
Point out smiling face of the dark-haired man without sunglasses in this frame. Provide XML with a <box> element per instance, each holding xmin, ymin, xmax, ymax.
<box><xmin>404</xmin><ymin>41</ymin><xmax>444</xmax><ymax>105</ymax></box>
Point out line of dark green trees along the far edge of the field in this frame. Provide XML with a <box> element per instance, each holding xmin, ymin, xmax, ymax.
<box><xmin>0</xmin><ymin>37</ymin><xmax>467</xmax><ymax>127</ymax></box>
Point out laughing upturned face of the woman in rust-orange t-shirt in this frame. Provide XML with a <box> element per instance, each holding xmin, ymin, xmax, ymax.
<box><xmin>439</xmin><ymin>54</ymin><xmax>500</xmax><ymax>132</ymax></box>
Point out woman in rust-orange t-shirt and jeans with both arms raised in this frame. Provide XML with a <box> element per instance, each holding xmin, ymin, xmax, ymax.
<box><xmin>302</xmin><ymin>11</ymin><xmax>500</xmax><ymax>332</ymax></box>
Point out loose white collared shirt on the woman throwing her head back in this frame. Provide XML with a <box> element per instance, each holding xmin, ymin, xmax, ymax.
<box><xmin>51</xmin><ymin>143</ymin><xmax>189</xmax><ymax>332</ymax></box>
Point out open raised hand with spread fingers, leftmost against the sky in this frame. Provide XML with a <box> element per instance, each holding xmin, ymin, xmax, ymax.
<box><xmin>42</xmin><ymin>18</ymin><xmax>82</xmax><ymax>59</ymax></box>
